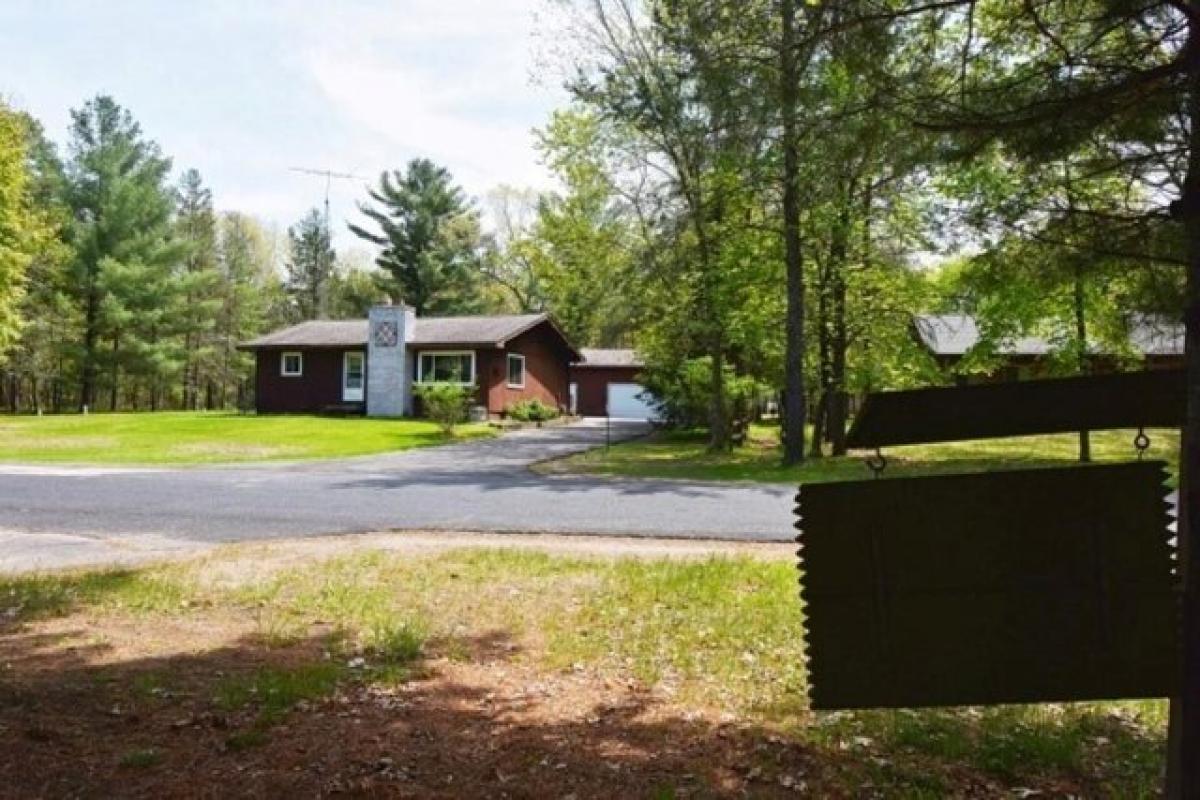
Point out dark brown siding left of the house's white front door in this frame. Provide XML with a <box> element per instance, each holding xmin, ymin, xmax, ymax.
<box><xmin>254</xmin><ymin>348</ymin><xmax>365</xmax><ymax>414</ymax></box>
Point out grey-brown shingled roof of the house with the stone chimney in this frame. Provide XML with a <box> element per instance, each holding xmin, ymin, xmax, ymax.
<box><xmin>241</xmin><ymin>314</ymin><xmax>577</xmax><ymax>356</ymax></box>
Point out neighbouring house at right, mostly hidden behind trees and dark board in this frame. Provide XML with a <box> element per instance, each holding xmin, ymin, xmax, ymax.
<box><xmin>913</xmin><ymin>314</ymin><xmax>1183</xmax><ymax>381</ymax></box>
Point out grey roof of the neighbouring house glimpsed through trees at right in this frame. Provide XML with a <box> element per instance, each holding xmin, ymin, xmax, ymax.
<box><xmin>913</xmin><ymin>314</ymin><xmax>1183</xmax><ymax>355</ymax></box>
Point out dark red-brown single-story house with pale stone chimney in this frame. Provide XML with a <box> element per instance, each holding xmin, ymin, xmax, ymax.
<box><xmin>240</xmin><ymin>306</ymin><xmax>583</xmax><ymax>416</ymax></box>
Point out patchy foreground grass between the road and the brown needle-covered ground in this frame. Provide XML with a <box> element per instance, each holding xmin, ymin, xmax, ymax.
<box><xmin>10</xmin><ymin>548</ymin><xmax>1166</xmax><ymax>796</ymax></box>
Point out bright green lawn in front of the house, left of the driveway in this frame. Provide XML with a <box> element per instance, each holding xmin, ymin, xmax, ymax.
<box><xmin>0</xmin><ymin>411</ymin><xmax>493</xmax><ymax>464</ymax></box>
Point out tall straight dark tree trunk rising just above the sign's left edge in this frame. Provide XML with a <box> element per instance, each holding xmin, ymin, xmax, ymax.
<box><xmin>779</xmin><ymin>0</ymin><xmax>808</xmax><ymax>465</ymax></box>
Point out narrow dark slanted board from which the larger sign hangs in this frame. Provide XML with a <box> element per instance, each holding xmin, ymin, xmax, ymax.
<box><xmin>848</xmin><ymin>369</ymin><xmax>1187</xmax><ymax>447</ymax></box>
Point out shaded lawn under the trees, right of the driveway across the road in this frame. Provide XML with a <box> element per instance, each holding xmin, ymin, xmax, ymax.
<box><xmin>551</xmin><ymin>426</ymin><xmax>1180</xmax><ymax>483</ymax></box>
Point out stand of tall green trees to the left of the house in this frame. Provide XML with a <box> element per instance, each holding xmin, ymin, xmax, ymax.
<box><xmin>0</xmin><ymin>97</ymin><xmax>290</xmax><ymax>410</ymax></box>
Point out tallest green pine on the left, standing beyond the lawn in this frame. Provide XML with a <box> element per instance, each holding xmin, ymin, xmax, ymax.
<box><xmin>66</xmin><ymin>95</ymin><xmax>179</xmax><ymax>407</ymax></box>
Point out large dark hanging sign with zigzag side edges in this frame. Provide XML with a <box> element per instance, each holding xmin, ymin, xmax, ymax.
<box><xmin>797</xmin><ymin>462</ymin><xmax>1180</xmax><ymax>709</ymax></box>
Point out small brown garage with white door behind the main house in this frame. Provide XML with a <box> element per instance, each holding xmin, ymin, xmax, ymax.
<box><xmin>570</xmin><ymin>348</ymin><xmax>655</xmax><ymax>420</ymax></box>
